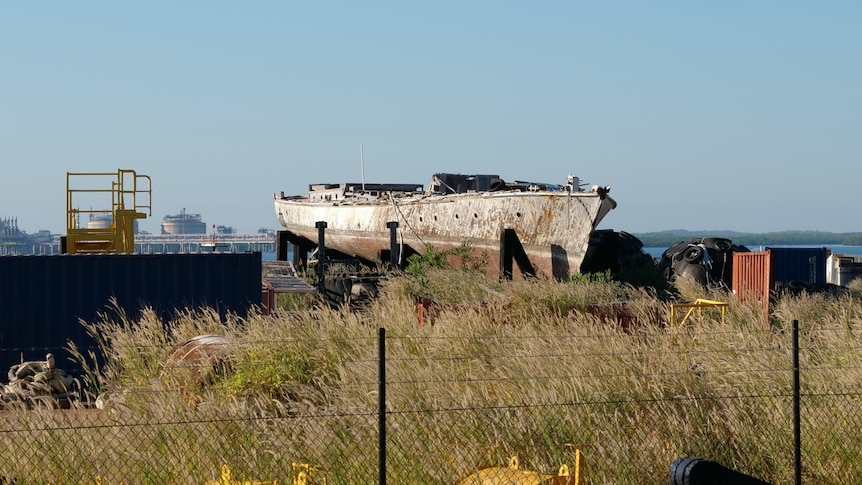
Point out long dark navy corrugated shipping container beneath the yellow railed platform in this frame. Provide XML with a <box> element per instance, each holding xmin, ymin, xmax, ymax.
<box><xmin>0</xmin><ymin>253</ymin><xmax>261</xmax><ymax>369</ymax></box>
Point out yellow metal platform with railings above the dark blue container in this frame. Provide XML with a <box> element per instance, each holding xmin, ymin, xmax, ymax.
<box><xmin>64</xmin><ymin>169</ymin><xmax>152</xmax><ymax>254</ymax></box>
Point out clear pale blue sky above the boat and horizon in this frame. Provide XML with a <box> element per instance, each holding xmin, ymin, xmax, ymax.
<box><xmin>0</xmin><ymin>1</ymin><xmax>862</xmax><ymax>233</ymax></box>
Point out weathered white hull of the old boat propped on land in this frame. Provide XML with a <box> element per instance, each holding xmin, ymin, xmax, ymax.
<box><xmin>275</xmin><ymin>187</ymin><xmax>616</xmax><ymax>278</ymax></box>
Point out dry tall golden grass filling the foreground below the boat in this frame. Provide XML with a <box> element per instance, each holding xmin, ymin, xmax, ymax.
<box><xmin>0</xmin><ymin>270</ymin><xmax>862</xmax><ymax>484</ymax></box>
